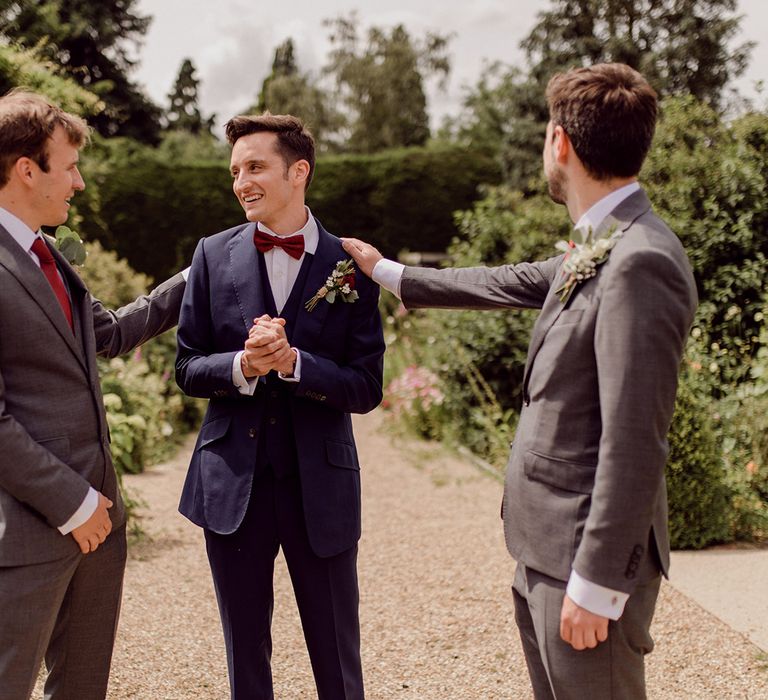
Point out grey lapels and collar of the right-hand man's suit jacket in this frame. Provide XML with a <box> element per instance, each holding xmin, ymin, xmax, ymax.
<box><xmin>523</xmin><ymin>190</ymin><xmax>651</xmax><ymax>394</ymax></box>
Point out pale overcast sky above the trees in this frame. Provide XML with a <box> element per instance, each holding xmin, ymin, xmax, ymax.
<box><xmin>134</xmin><ymin>0</ymin><xmax>768</xmax><ymax>132</ymax></box>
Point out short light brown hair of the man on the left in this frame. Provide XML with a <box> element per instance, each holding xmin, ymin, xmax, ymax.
<box><xmin>0</xmin><ymin>88</ymin><xmax>90</xmax><ymax>187</ymax></box>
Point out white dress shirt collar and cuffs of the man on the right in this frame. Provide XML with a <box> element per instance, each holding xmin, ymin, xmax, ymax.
<box><xmin>371</xmin><ymin>181</ymin><xmax>640</xmax><ymax>620</ymax></box>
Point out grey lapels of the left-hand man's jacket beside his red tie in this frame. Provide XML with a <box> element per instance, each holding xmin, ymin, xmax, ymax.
<box><xmin>0</xmin><ymin>226</ymin><xmax>88</xmax><ymax>372</ymax></box>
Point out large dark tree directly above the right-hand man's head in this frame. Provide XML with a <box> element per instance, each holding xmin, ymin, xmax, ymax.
<box><xmin>522</xmin><ymin>0</ymin><xmax>754</xmax><ymax>107</ymax></box>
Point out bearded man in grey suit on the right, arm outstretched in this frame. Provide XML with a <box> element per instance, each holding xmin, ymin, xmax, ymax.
<box><xmin>345</xmin><ymin>64</ymin><xmax>697</xmax><ymax>700</ymax></box>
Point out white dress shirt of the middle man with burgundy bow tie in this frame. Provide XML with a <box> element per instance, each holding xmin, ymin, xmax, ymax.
<box><xmin>232</xmin><ymin>206</ymin><xmax>320</xmax><ymax>396</ymax></box>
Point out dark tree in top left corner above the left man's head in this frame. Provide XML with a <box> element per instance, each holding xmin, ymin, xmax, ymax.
<box><xmin>0</xmin><ymin>0</ymin><xmax>161</xmax><ymax>143</ymax></box>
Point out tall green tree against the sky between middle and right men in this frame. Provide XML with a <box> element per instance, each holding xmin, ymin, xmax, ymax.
<box><xmin>325</xmin><ymin>14</ymin><xmax>450</xmax><ymax>153</ymax></box>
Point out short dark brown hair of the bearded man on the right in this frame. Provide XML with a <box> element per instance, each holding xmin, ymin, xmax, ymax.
<box><xmin>547</xmin><ymin>63</ymin><xmax>658</xmax><ymax>180</ymax></box>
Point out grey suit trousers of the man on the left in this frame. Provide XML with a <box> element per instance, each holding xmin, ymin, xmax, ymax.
<box><xmin>0</xmin><ymin>526</ymin><xmax>127</xmax><ymax>700</ymax></box>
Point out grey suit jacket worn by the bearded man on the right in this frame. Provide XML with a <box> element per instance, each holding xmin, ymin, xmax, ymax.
<box><xmin>401</xmin><ymin>191</ymin><xmax>697</xmax><ymax>593</ymax></box>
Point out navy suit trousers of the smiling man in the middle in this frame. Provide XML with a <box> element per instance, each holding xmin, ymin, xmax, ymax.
<box><xmin>205</xmin><ymin>468</ymin><xmax>364</xmax><ymax>700</ymax></box>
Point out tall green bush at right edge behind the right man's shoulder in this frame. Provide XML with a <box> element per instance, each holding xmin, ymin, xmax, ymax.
<box><xmin>641</xmin><ymin>97</ymin><xmax>768</xmax><ymax>382</ymax></box>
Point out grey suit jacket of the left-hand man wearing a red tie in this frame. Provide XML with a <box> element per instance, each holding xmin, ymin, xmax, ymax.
<box><xmin>0</xmin><ymin>226</ymin><xmax>185</xmax><ymax>566</ymax></box>
